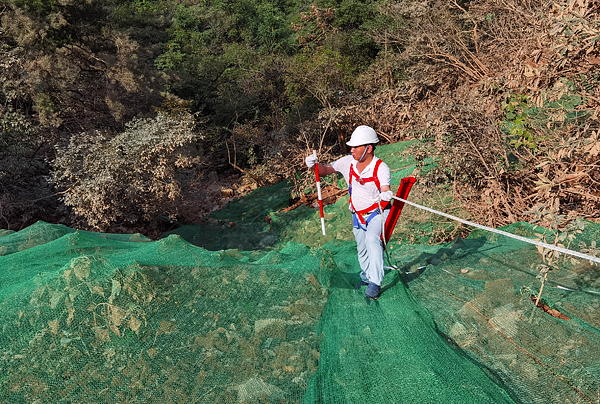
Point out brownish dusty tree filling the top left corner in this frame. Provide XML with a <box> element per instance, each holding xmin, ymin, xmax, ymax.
<box><xmin>0</xmin><ymin>0</ymin><xmax>161</xmax><ymax>134</ymax></box>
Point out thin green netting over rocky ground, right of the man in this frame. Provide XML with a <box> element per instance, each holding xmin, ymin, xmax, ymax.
<box><xmin>397</xmin><ymin>223</ymin><xmax>600</xmax><ymax>403</ymax></box>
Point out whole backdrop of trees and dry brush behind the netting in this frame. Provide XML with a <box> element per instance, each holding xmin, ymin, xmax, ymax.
<box><xmin>0</xmin><ymin>0</ymin><xmax>600</xmax><ymax>237</ymax></box>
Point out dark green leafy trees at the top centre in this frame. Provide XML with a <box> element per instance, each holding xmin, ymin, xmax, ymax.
<box><xmin>155</xmin><ymin>0</ymin><xmax>384</xmax><ymax>121</ymax></box>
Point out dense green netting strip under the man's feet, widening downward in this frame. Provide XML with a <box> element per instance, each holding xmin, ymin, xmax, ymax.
<box><xmin>304</xmin><ymin>242</ymin><xmax>514</xmax><ymax>403</ymax></box>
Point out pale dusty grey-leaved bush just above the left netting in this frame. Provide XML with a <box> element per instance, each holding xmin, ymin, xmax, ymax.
<box><xmin>53</xmin><ymin>114</ymin><xmax>198</xmax><ymax>229</ymax></box>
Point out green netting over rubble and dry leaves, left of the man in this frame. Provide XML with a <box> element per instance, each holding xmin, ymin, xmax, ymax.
<box><xmin>0</xmin><ymin>223</ymin><xmax>330</xmax><ymax>403</ymax></box>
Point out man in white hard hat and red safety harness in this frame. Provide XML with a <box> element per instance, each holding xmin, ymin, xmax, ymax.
<box><xmin>306</xmin><ymin>125</ymin><xmax>394</xmax><ymax>300</ymax></box>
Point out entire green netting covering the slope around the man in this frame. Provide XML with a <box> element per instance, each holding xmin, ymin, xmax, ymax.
<box><xmin>0</xmin><ymin>145</ymin><xmax>600</xmax><ymax>404</ymax></box>
